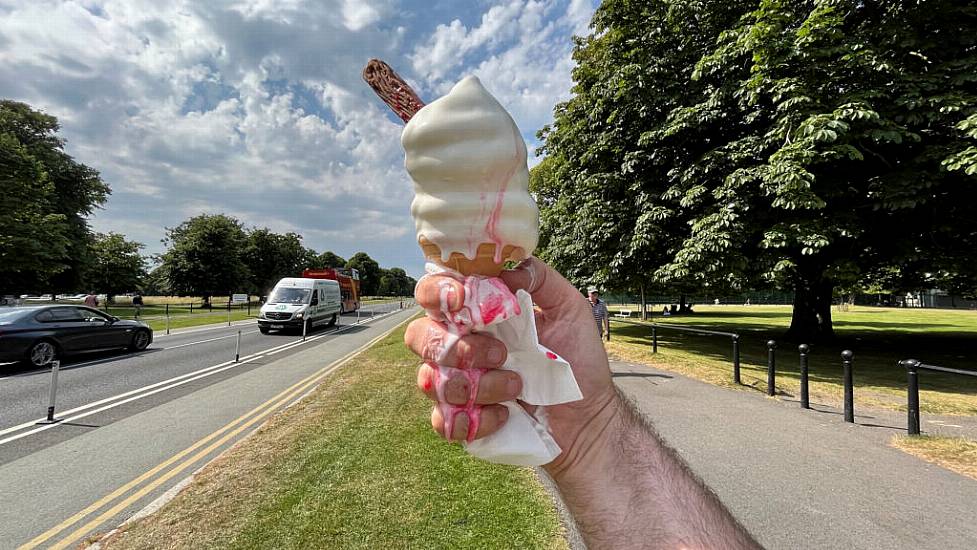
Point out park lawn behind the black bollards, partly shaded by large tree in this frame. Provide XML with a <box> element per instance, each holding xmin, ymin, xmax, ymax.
<box><xmin>608</xmin><ymin>306</ymin><xmax>977</xmax><ymax>415</ymax></box>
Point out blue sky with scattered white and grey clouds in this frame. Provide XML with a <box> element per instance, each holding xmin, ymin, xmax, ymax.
<box><xmin>0</xmin><ymin>0</ymin><xmax>597</xmax><ymax>277</ymax></box>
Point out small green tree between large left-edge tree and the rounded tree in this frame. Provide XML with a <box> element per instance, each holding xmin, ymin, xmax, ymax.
<box><xmin>84</xmin><ymin>233</ymin><xmax>146</xmax><ymax>302</ymax></box>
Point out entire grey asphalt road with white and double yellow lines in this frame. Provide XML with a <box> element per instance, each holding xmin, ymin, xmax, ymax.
<box><xmin>0</xmin><ymin>304</ymin><xmax>413</xmax><ymax>548</ymax></box>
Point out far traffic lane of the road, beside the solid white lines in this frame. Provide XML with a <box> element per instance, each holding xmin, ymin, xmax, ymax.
<box><xmin>0</xmin><ymin>302</ymin><xmax>400</xmax><ymax>464</ymax></box>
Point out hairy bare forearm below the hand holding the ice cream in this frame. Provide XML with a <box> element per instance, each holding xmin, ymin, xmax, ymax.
<box><xmin>550</xmin><ymin>395</ymin><xmax>759</xmax><ymax>549</ymax></box>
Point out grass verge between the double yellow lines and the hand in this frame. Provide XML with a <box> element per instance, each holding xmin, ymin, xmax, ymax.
<box><xmin>101</xmin><ymin>322</ymin><xmax>567</xmax><ymax>549</ymax></box>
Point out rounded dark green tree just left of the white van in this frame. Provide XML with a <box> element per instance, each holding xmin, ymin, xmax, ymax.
<box><xmin>160</xmin><ymin>214</ymin><xmax>251</xmax><ymax>302</ymax></box>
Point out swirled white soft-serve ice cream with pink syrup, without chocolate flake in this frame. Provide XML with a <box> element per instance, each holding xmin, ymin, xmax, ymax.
<box><xmin>401</xmin><ymin>76</ymin><xmax>539</xmax><ymax>274</ymax></box>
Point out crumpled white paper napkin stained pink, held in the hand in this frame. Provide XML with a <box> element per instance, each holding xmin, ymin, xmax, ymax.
<box><xmin>427</xmin><ymin>264</ymin><xmax>583</xmax><ymax>466</ymax></box>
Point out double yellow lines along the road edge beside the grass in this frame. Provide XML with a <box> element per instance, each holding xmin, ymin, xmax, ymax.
<box><xmin>18</xmin><ymin>318</ymin><xmax>410</xmax><ymax>550</ymax></box>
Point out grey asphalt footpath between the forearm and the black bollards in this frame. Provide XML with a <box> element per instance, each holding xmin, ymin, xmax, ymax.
<box><xmin>612</xmin><ymin>363</ymin><xmax>977</xmax><ymax>550</ymax></box>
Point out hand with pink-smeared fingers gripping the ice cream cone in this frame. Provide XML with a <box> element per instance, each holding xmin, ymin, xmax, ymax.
<box><xmin>405</xmin><ymin>258</ymin><xmax>616</xmax><ymax>475</ymax></box>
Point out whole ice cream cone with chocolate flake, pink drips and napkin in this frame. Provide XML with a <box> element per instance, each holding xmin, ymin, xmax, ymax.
<box><xmin>363</xmin><ymin>60</ymin><xmax>582</xmax><ymax>466</ymax></box>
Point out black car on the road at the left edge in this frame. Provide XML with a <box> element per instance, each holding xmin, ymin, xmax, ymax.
<box><xmin>0</xmin><ymin>305</ymin><xmax>153</xmax><ymax>367</ymax></box>
